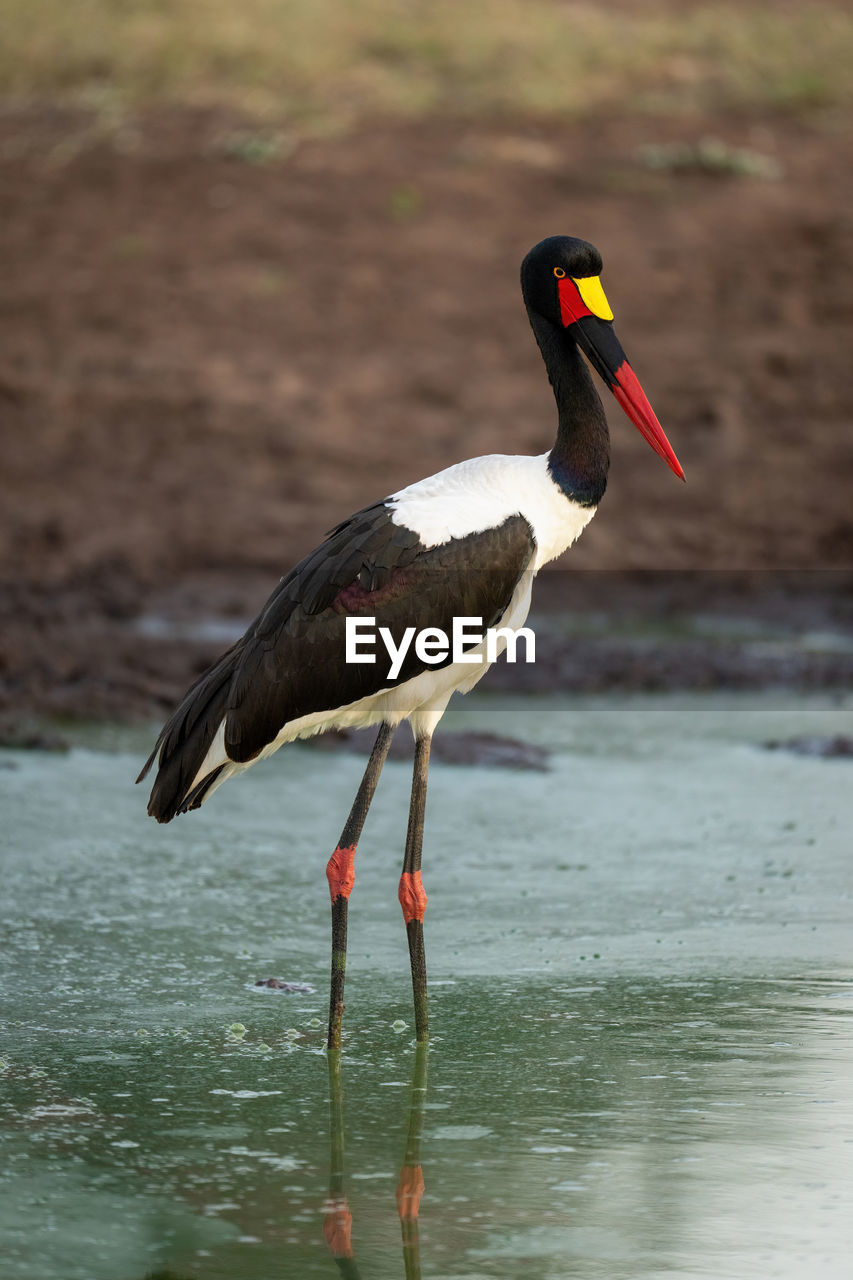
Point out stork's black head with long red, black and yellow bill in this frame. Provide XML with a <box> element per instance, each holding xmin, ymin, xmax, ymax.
<box><xmin>521</xmin><ymin>236</ymin><xmax>684</xmax><ymax>480</ymax></box>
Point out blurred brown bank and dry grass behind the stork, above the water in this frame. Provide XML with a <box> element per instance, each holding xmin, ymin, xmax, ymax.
<box><xmin>0</xmin><ymin>0</ymin><xmax>853</xmax><ymax>740</ymax></box>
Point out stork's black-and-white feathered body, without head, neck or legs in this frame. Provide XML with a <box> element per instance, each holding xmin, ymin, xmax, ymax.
<box><xmin>140</xmin><ymin>465</ymin><xmax>584</xmax><ymax>822</ymax></box>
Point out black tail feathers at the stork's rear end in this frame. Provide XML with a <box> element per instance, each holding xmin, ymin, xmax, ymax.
<box><xmin>136</xmin><ymin>643</ymin><xmax>241</xmax><ymax>822</ymax></box>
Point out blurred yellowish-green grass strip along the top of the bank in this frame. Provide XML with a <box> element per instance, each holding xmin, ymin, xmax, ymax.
<box><xmin>0</xmin><ymin>0</ymin><xmax>853</xmax><ymax>125</ymax></box>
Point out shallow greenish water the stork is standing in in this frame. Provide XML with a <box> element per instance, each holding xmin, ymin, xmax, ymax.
<box><xmin>0</xmin><ymin>695</ymin><xmax>853</xmax><ymax>1280</ymax></box>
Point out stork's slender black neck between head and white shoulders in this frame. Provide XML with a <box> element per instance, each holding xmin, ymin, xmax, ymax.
<box><xmin>528</xmin><ymin>311</ymin><xmax>610</xmax><ymax>507</ymax></box>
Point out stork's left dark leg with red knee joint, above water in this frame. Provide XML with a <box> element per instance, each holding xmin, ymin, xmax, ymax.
<box><xmin>325</xmin><ymin>722</ymin><xmax>396</xmax><ymax>1048</ymax></box>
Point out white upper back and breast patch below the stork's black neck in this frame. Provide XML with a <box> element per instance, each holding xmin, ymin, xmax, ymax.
<box><xmin>391</xmin><ymin>453</ymin><xmax>596</xmax><ymax>573</ymax></box>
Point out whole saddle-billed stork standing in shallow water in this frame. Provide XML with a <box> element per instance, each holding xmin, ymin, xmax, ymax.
<box><xmin>140</xmin><ymin>236</ymin><xmax>684</xmax><ymax>1048</ymax></box>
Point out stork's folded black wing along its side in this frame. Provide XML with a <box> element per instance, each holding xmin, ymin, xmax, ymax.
<box><xmin>141</xmin><ymin>502</ymin><xmax>534</xmax><ymax>822</ymax></box>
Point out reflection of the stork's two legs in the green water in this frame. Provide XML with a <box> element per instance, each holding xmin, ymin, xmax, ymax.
<box><xmin>323</xmin><ymin>1042</ymin><xmax>428</xmax><ymax>1280</ymax></box>
